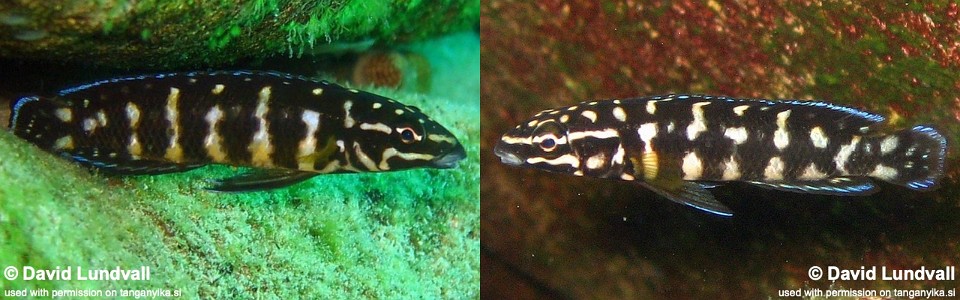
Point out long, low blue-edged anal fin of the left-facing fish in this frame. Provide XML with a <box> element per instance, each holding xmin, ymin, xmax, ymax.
<box><xmin>749</xmin><ymin>177</ymin><xmax>877</xmax><ymax>196</ymax></box>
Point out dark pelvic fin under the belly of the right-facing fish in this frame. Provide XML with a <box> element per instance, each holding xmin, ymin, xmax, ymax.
<box><xmin>206</xmin><ymin>169</ymin><xmax>320</xmax><ymax>192</ymax></box>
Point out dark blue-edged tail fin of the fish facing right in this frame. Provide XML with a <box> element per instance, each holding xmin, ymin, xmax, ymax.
<box><xmin>10</xmin><ymin>96</ymin><xmax>72</xmax><ymax>149</ymax></box>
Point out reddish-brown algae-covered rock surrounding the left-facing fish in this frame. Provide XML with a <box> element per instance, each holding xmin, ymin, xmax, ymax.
<box><xmin>480</xmin><ymin>0</ymin><xmax>960</xmax><ymax>298</ymax></box>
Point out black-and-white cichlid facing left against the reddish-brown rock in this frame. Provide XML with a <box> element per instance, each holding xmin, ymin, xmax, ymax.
<box><xmin>494</xmin><ymin>95</ymin><xmax>947</xmax><ymax>216</ymax></box>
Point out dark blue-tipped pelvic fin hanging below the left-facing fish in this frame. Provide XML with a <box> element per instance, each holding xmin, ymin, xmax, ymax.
<box><xmin>640</xmin><ymin>180</ymin><xmax>733</xmax><ymax>217</ymax></box>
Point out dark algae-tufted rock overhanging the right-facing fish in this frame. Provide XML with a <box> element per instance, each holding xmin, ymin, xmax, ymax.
<box><xmin>0</xmin><ymin>0</ymin><xmax>480</xmax><ymax>68</ymax></box>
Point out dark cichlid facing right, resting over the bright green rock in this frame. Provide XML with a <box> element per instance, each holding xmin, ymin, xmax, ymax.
<box><xmin>10</xmin><ymin>71</ymin><xmax>466</xmax><ymax>191</ymax></box>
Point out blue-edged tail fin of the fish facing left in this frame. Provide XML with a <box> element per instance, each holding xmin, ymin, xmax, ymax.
<box><xmin>870</xmin><ymin>125</ymin><xmax>947</xmax><ymax>190</ymax></box>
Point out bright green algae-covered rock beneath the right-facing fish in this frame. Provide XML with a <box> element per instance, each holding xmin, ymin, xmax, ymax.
<box><xmin>0</xmin><ymin>34</ymin><xmax>480</xmax><ymax>299</ymax></box>
